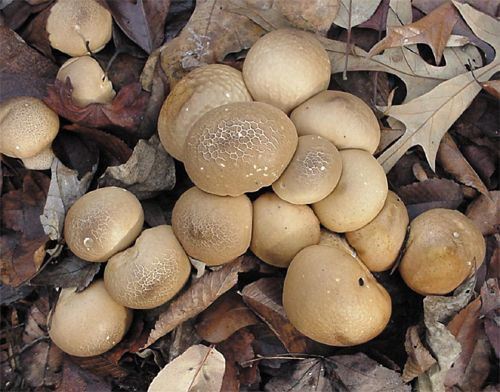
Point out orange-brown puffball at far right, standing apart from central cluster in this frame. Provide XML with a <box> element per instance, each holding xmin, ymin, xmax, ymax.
<box><xmin>399</xmin><ymin>208</ymin><xmax>486</xmax><ymax>295</ymax></box>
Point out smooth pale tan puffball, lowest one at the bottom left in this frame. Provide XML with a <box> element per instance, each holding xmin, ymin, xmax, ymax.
<box><xmin>49</xmin><ymin>280</ymin><xmax>133</xmax><ymax>357</ymax></box>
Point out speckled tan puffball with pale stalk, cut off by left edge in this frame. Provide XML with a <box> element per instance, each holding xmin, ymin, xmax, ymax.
<box><xmin>0</xmin><ymin>97</ymin><xmax>59</xmax><ymax>170</ymax></box>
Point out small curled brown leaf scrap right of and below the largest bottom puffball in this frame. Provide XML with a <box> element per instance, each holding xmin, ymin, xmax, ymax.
<box><xmin>402</xmin><ymin>325</ymin><xmax>436</xmax><ymax>383</ymax></box>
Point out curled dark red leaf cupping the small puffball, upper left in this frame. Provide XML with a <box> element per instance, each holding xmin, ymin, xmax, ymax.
<box><xmin>44</xmin><ymin>78</ymin><xmax>149</xmax><ymax>135</ymax></box>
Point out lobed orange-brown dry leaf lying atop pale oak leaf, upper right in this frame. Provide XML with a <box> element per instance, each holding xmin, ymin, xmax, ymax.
<box><xmin>368</xmin><ymin>2</ymin><xmax>458</xmax><ymax>64</ymax></box>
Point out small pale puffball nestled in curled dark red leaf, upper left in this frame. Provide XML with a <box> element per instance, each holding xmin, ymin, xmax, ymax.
<box><xmin>57</xmin><ymin>56</ymin><xmax>115</xmax><ymax>107</ymax></box>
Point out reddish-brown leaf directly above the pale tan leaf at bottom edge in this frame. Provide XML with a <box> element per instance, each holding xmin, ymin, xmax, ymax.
<box><xmin>196</xmin><ymin>291</ymin><xmax>258</xmax><ymax>343</ymax></box>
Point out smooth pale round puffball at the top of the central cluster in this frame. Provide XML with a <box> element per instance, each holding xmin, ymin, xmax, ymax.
<box><xmin>243</xmin><ymin>29</ymin><xmax>331</xmax><ymax>113</ymax></box>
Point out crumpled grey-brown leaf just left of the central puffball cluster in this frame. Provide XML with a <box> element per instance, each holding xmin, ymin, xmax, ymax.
<box><xmin>99</xmin><ymin>135</ymin><xmax>175</xmax><ymax>200</ymax></box>
